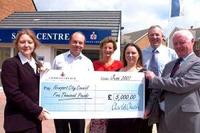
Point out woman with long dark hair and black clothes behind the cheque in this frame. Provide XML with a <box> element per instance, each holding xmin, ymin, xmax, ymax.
<box><xmin>107</xmin><ymin>43</ymin><xmax>150</xmax><ymax>133</ymax></box>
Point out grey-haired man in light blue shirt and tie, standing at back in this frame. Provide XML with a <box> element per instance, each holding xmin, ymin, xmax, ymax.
<box><xmin>142</xmin><ymin>25</ymin><xmax>177</xmax><ymax>133</ymax></box>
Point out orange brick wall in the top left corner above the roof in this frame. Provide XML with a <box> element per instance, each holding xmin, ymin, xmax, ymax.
<box><xmin>0</xmin><ymin>0</ymin><xmax>36</xmax><ymax>21</ymax></box>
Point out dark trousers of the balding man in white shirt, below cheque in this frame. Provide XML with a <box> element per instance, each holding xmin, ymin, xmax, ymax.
<box><xmin>54</xmin><ymin>119</ymin><xmax>85</xmax><ymax>133</ymax></box>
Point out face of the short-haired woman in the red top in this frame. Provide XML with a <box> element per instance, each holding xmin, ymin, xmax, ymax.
<box><xmin>101</xmin><ymin>42</ymin><xmax>115</xmax><ymax>59</ymax></box>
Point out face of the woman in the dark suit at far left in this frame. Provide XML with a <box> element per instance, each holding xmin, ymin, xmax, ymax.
<box><xmin>17</xmin><ymin>34</ymin><xmax>35</xmax><ymax>59</ymax></box>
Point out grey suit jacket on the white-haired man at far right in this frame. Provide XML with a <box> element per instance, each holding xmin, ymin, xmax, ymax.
<box><xmin>150</xmin><ymin>53</ymin><xmax>200</xmax><ymax>133</ymax></box>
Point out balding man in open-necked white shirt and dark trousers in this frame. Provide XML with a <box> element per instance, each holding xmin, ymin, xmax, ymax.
<box><xmin>52</xmin><ymin>32</ymin><xmax>94</xmax><ymax>133</ymax></box>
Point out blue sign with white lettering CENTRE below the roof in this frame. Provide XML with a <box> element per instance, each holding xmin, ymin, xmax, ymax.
<box><xmin>0</xmin><ymin>28</ymin><xmax>111</xmax><ymax>45</ymax></box>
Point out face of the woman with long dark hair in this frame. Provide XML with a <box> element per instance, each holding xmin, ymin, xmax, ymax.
<box><xmin>125</xmin><ymin>46</ymin><xmax>139</xmax><ymax>65</ymax></box>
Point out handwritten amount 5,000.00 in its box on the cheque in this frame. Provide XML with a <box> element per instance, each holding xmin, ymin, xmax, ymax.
<box><xmin>113</xmin><ymin>93</ymin><xmax>136</xmax><ymax>101</ymax></box>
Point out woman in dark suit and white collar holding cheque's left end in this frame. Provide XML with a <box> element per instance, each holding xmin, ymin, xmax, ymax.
<box><xmin>1</xmin><ymin>29</ymin><xmax>48</xmax><ymax>133</ymax></box>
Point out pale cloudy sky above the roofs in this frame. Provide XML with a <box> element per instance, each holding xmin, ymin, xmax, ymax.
<box><xmin>34</xmin><ymin>0</ymin><xmax>200</xmax><ymax>34</ymax></box>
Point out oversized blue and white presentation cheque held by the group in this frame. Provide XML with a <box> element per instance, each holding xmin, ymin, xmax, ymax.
<box><xmin>40</xmin><ymin>70</ymin><xmax>145</xmax><ymax>119</ymax></box>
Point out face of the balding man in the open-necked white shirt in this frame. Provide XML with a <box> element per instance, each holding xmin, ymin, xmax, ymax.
<box><xmin>69</xmin><ymin>32</ymin><xmax>85</xmax><ymax>57</ymax></box>
